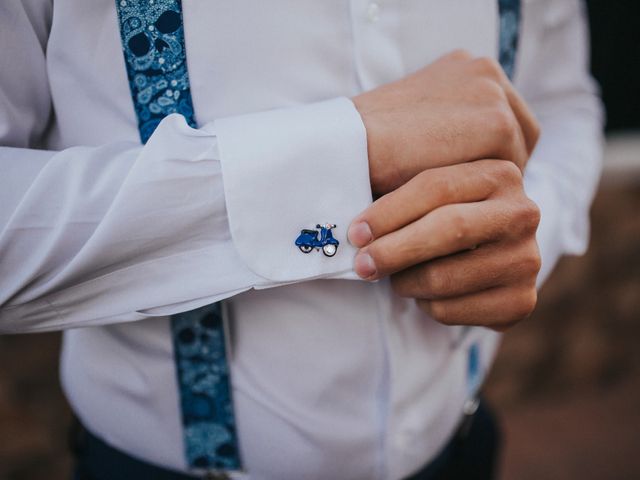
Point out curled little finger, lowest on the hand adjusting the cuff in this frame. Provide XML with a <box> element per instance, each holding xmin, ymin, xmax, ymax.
<box><xmin>416</xmin><ymin>284</ymin><xmax>537</xmax><ymax>331</ymax></box>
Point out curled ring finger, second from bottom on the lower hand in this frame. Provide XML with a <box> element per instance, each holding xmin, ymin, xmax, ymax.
<box><xmin>391</xmin><ymin>239</ymin><xmax>540</xmax><ymax>300</ymax></box>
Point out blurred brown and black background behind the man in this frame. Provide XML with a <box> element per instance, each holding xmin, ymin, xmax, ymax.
<box><xmin>0</xmin><ymin>0</ymin><xmax>640</xmax><ymax>480</ymax></box>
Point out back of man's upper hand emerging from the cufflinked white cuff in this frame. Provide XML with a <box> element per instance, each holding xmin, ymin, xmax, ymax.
<box><xmin>353</xmin><ymin>51</ymin><xmax>539</xmax><ymax>194</ymax></box>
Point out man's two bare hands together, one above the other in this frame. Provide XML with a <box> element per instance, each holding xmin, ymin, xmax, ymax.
<box><xmin>348</xmin><ymin>52</ymin><xmax>540</xmax><ymax>330</ymax></box>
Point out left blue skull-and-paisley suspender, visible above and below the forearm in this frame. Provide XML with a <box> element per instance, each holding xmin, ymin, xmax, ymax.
<box><xmin>116</xmin><ymin>0</ymin><xmax>242</xmax><ymax>472</ymax></box>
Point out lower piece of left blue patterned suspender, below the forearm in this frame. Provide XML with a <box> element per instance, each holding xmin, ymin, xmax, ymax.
<box><xmin>171</xmin><ymin>303</ymin><xmax>241</xmax><ymax>470</ymax></box>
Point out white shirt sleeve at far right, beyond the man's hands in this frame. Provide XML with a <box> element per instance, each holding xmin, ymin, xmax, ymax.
<box><xmin>515</xmin><ymin>0</ymin><xmax>603</xmax><ymax>285</ymax></box>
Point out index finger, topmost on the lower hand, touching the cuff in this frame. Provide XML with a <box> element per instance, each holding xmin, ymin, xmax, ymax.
<box><xmin>348</xmin><ymin>160</ymin><xmax>508</xmax><ymax>247</ymax></box>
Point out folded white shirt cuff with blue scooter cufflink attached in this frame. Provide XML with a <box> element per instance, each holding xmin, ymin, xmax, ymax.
<box><xmin>213</xmin><ymin>98</ymin><xmax>372</xmax><ymax>283</ymax></box>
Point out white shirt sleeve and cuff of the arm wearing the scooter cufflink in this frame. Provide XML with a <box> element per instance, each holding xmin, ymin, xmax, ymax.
<box><xmin>0</xmin><ymin>2</ymin><xmax>371</xmax><ymax>332</ymax></box>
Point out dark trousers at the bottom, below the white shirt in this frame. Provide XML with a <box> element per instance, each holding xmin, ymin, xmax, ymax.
<box><xmin>72</xmin><ymin>402</ymin><xmax>500</xmax><ymax>480</ymax></box>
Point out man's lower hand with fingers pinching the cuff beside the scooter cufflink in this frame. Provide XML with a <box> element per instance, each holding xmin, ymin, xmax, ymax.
<box><xmin>348</xmin><ymin>160</ymin><xmax>540</xmax><ymax>330</ymax></box>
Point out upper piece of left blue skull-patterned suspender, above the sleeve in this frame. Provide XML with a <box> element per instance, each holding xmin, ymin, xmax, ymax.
<box><xmin>116</xmin><ymin>0</ymin><xmax>196</xmax><ymax>143</ymax></box>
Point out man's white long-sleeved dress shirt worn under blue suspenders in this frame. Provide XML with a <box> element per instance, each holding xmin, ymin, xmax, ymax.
<box><xmin>0</xmin><ymin>0</ymin><xmax>601</xmax><ymax>480</ymax></box>
